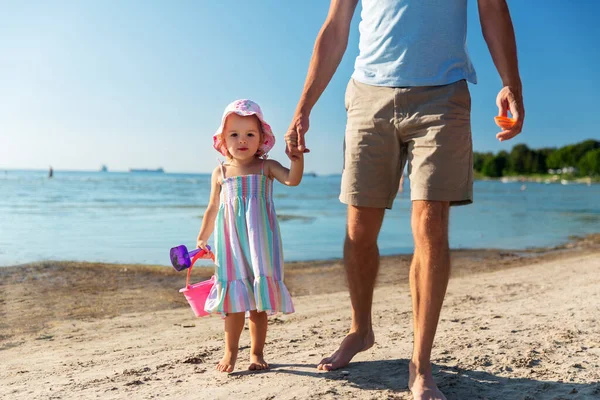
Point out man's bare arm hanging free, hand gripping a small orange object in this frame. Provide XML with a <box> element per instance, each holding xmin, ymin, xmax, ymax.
<box><xmin>477</xmin><ymin>0</ymin><xmax>525</xmax><ymax>141</ymax></box>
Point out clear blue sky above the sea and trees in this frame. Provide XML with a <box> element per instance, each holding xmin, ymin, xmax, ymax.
<box><xmin>0</xmin><ymin>0</ymin><xmax>600</xmax><ymax>173</ymax></box>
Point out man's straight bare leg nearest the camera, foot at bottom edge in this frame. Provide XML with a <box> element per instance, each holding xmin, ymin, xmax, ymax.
<box><xmin>408</xmin><ymin>201</ymin><xmax>450</xmax><ymax>400</ymax></box>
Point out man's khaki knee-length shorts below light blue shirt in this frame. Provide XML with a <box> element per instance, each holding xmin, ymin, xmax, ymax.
<box><xmin>340</xmin><ymin>79</ymin><xmax>473</xmax><ymax>208</ymax></box>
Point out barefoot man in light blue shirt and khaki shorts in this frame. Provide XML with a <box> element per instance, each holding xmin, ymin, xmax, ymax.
<box><xmin>286</xmin><ymin>0</ymin><xmax>524</xmax><ymax>399</ymax></box>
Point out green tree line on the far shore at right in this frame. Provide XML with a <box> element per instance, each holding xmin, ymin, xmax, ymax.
<box><xmin>473</xmin><ymin>139</ymin><xmax>600</xmax><ymax>178</ymax></box>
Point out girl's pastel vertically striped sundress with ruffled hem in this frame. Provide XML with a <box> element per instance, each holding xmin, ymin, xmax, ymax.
<box><xmin>204</xmin><ymin>165</ymin><xmax>294</xmax><ymax>315</ymax></box>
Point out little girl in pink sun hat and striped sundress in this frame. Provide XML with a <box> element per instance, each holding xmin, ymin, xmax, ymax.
<box><xmin>197</xmin><ymin>100</ymin><xmax>304</xmax><ymax>372</ymax></box>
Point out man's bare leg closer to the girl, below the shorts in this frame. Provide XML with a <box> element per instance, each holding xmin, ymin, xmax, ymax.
<box><xmin>317</xmin><ymin>206</ymin><xmax>385</xmax><ymax>371</ymax></box>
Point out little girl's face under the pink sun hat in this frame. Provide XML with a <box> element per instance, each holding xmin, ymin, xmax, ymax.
<box><xmin>223</xmin><ymin>113</ymin><xmax>262</xmax><ymax>160</ymax></box>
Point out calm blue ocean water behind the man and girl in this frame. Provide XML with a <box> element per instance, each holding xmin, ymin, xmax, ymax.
<box><xmin>0</xmin><ymin>171</ymin><xmax>600</xmax><ymax>266</ymax></box>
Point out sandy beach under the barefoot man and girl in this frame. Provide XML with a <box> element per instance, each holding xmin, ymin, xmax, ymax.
<box><xmin>0</xmin><ymin>235</ymin><xmax>600</xmax><ymax>400</ymax></box>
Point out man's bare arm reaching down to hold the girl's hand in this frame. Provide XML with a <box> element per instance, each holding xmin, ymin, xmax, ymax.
<box><xmin>286</xmin><ymin>0</ymin><xmax>358</xmax><ymax>155</ymax></box>
